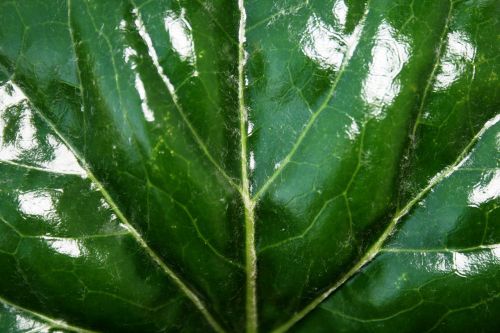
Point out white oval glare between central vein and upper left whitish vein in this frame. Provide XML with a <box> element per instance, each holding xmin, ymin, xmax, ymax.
<box><xmin>164</xmin><ymin>8</ymin><xmax>196</xmax><ymax>65</ymax></box>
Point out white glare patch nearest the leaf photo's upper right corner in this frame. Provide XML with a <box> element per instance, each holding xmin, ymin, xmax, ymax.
<box><xmin>434</xmin><ymin>31</ymin><xmax>476</xmax><ymax>91</ymax></box>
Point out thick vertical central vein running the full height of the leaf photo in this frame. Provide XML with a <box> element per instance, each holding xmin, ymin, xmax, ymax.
<box><xmin>238</xmin><ymin>0</ymin><xmax>257</xmax><ymax>333</ymax></box>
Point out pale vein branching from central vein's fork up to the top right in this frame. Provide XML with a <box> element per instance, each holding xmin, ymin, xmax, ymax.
<box><xmin>253</xmin><ymin>2</ymin><xmax>370</xmax><ymax>200</ymax></box>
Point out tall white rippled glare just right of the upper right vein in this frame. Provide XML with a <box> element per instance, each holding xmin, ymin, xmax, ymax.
<box><xmin>363</xmin><ymin>22</ymin><xmax>410</xmax><ymax>119</ymax></box>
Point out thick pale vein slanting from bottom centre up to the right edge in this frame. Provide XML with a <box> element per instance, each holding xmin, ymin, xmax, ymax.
<box><xmin>273</xmin><ymin>115</ymin><xmax>500</xmax><ymax>333</ymax></box>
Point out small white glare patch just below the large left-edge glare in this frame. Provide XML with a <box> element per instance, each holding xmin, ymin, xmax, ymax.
<box><xmin>17</xmin><ymin>191</ymin><xmax>57</xmax><ymax>219</ymax></box>
